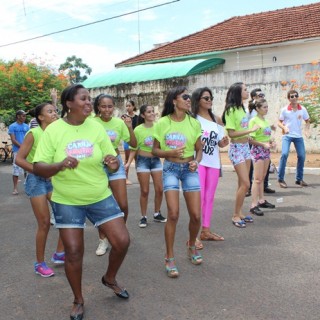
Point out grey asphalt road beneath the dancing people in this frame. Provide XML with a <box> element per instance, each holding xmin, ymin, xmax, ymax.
<box><xmin>0</xmin><ymin>164</ymin><xmax>320</xmax><ymax>320</ymax></box>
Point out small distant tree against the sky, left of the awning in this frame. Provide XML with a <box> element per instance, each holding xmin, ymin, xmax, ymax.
<box><xmin>59</xmin><ymin>56</ymin><xmax>92</xmax><ymax>83</ymax></box>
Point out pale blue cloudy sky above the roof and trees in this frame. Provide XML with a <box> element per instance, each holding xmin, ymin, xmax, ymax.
<box><xmin>0</xmin><ymin>0</ymin><xmax>319</xmax><ymax>74</ymax></box>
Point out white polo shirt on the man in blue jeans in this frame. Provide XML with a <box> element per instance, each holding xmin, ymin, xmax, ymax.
<box><xmin>279</xmin><ymin>104</ymin><xmax>309</xmax><ymax>138</ymax></box>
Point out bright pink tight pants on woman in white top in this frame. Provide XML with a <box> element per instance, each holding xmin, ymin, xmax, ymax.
<box><xmin>198</xmin><ymin>165</ymin><xmax>220</xmax><ymax>228</ymax></box>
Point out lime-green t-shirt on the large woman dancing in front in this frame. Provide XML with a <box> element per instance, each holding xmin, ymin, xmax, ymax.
<box><xmin>33</xmin><ymin>119</ymin><xmax>116</xmax><ymax>205</ymax></box>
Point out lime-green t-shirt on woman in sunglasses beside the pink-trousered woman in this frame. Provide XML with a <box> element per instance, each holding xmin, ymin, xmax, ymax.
<box><xmin>153</xmin><ymin>115</ymin><xmax>201</xmax><ymax>158</ymax></box>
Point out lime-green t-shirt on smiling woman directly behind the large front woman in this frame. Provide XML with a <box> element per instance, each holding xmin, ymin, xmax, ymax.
<box><xmin>94</xmin><ymin>117</ymin><xmax>130</xmax><ymax>149</ymax></box>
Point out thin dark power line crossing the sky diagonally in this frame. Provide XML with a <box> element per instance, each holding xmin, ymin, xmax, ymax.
<box><xmin>0</xmin><ymin>0</ymin><xmax>180</xmax><ymax>48</ymax></box>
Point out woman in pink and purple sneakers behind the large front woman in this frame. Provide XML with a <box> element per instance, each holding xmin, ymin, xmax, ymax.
<box><xmin>16</xmin><ymin>103</ymin><xmax>65</xmax><ymax>277</ymax></box>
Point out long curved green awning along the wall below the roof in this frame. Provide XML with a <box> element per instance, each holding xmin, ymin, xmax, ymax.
<box><xmin>82</xmin><ymin>58</ymin><xmax>225</xmax><ymax>89</ymax></box>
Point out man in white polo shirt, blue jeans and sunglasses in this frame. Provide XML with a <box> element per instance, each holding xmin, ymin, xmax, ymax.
<box><xmin>278</xmin><ymin>90</ymin><xmax>310</xmax><ymax>188</ymax></box>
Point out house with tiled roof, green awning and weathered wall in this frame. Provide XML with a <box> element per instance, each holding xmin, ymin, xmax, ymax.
<box><xmin>84</xmin><ymin>2</ymin><xmax>320</xmax><ymax>152</ymax></box>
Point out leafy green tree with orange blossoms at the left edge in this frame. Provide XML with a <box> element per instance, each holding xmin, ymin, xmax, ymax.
<box><xmin>0</xmin><ymin>60</ymin><xmax>68</xmax><ymax>125</ymax></box>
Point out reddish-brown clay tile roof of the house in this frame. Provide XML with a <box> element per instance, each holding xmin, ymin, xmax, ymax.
<box><xmin>116</xmin><ymin>2</ymin><xmax>320</xmax><ymax>67</ymax></box>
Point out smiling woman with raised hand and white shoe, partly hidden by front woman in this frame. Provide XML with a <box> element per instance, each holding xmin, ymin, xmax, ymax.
<box><xmin>93</xmin><ymin>93</ymin><xmax>137</xmax><ymax>256</ymax></box>
